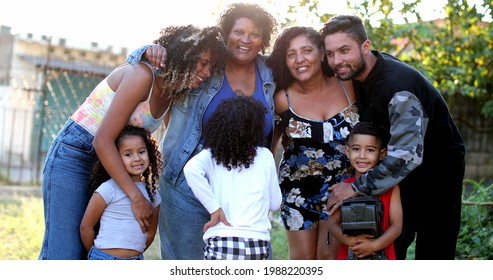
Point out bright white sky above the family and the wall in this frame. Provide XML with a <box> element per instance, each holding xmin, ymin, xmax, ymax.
<box><xmin>0</xmin><ymin>0</ymin><xmax>446</xmax><ymax>50</ymax></box>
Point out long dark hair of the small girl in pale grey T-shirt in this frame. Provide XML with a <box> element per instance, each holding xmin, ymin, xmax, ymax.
<box><xmin>89</xmin><ymin>125</ymin><xmax>163</xmax><ymax>202</ymax></box>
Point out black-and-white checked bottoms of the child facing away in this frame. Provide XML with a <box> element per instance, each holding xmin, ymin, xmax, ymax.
<box><xmin>204</xmin><ymin>236</ymin><xmax>270</xmax><ymax>260</ymax></box>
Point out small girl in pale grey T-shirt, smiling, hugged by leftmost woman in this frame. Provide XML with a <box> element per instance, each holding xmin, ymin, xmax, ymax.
<box><xmin>80</xmin><ymin>125</ymin><xmax>163</xmax><ymax>260</ymax></box>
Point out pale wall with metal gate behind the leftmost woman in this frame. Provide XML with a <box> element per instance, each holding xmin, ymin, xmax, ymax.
<box><xmin>0</xmin><ymin>26</ymin><xmax>133</xmax><ymax>183</ymax></box>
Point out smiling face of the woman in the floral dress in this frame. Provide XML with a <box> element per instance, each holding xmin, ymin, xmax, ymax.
<box><xmin>286</xmin><ymin>35</ymin><xmax>324</xmax><ymax>81</ymax></box>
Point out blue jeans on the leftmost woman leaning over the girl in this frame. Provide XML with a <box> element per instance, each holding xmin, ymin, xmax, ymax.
<box><xmin>39</xmin><ymin>119</ymin><xmax>97</xmax><ymax>260</ymax></box>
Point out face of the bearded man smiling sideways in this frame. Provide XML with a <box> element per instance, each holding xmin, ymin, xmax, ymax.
<box><xmin>324</xmin><ymin>32</ymin><xmax>370</xmax><ymax>81</ymax></box>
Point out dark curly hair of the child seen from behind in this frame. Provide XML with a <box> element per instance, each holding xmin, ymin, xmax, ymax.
<box><xmin>203</xmin><ymin>96</ymin><xmax>267</xmax><ymax>170</ymax></box>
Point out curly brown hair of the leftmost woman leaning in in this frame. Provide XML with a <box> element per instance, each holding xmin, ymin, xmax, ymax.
<box><xmin>154</xmin><ymin>25</ymin><xmax>227</xmax><ymax>99</ymax></box>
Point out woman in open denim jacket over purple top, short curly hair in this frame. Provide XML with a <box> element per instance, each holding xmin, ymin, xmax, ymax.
<box><xmin>127</xmin><ymin>3</ymin><xmax>277</xmax><ymax>260</ymax></box>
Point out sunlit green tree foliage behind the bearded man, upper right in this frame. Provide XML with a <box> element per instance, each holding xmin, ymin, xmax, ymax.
<box><xmin>286</xmin><ymin>0</ymin><xmax>493</xmax><ymax>117</ymax></box>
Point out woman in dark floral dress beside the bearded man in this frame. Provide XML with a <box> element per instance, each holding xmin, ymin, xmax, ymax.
<box><xmin>267</xmin><ymin>26</ymin><xmax>359</xmax><ymax>259</ymax></box>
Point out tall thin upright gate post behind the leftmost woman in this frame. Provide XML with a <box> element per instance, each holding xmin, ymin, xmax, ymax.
<box><xmin>36</xmin><ymin>36</ymin><xmax>51</xmax><ymax>182</ymax></box>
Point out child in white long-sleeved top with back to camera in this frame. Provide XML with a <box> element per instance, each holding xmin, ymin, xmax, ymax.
<box><xmin>183</xmin><ymin>97</ymin><xmax>281</xmax><ymax>260</ymax></box>
